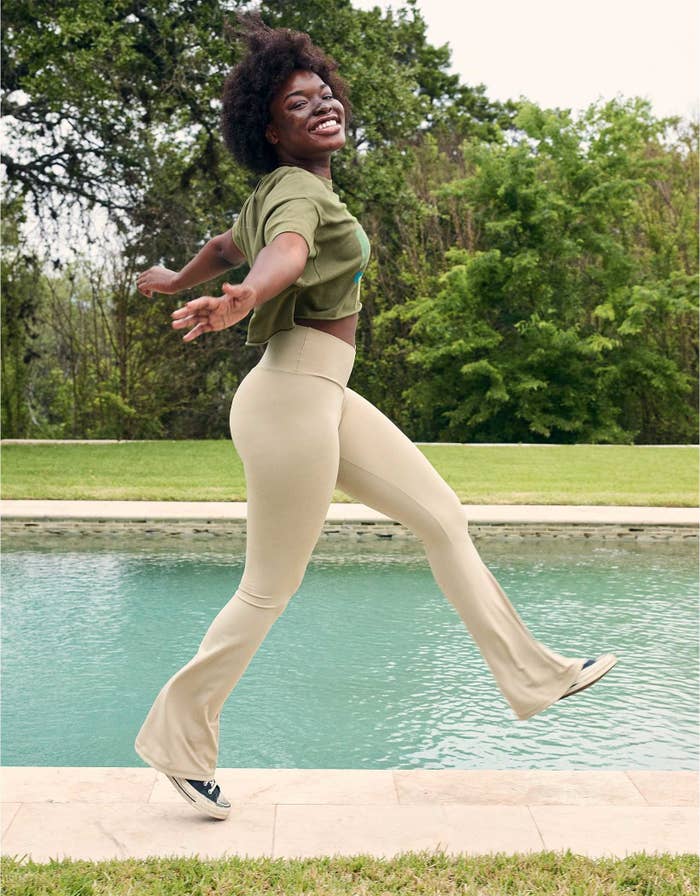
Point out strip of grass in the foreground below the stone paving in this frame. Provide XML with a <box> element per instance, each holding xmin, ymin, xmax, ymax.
<box><xmin>0</xmin><ymin>851</ymin><xmax>699</xmax><ymax>896</ymax></box>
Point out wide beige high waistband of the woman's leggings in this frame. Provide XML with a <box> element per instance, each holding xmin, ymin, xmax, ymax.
<box><xmin>258</xmin><ymin>324</ymin><xmax>356</xmax><ymax>389</ymax></box>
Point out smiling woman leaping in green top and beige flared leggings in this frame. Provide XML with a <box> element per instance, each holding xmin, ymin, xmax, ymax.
<box><xmin>135</xmin><ymin>20</ymin><xmax>617</xmax><ymax>818</ymax></box>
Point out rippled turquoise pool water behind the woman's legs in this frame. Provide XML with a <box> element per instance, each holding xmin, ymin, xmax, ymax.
<box><xmin>1</xmin><ymin>536</ymin><xmax>699</xmax><ymax>769</ymax></box>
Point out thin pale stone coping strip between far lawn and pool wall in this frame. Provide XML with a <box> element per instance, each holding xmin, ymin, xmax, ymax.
<box><xmin>0</xmin><ymin>501</ymin><xmax>700</xmax><ymax>526</ymax></box>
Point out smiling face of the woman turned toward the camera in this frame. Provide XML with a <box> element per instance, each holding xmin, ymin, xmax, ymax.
<box><xmin>265</xmin><ymin>69</ymin><xmax>345</xmax><ymax>164</ymax></box>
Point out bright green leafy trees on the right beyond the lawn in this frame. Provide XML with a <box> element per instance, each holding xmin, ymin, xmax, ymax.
<box><xmin>370</xmin><ymin>101</ymin><xmax>697</xmax><ymax>442</ymax></box>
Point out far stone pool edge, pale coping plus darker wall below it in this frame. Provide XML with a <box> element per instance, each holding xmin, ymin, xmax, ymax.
<box><xmin>0</xmin><ymin>501</ymin><xmax>700</xmax><ymax>543</ymax></box>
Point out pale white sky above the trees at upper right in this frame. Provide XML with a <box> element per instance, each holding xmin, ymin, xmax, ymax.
<box><xmin>353</xmin><ymin>0</ymin><xmax>700</xmax><ymax>118</ymax></box>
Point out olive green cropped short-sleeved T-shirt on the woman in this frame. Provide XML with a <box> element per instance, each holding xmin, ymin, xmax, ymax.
<box><xmin>231</xmin><ymin>165</ymin><xmax>370</xmax><ymax>345</ymax></box>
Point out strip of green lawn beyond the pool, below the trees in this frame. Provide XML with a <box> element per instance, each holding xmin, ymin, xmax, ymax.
<box><xmin>2</xmin><ymin>440</ymin><xmax>698</xmax><ymax>507</ymax></box>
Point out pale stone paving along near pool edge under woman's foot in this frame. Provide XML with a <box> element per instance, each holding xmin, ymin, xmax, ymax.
<box><xmin>0</xmin><ymin>767</ymin><xmax>700</xmax><ymax>862</ymax></box>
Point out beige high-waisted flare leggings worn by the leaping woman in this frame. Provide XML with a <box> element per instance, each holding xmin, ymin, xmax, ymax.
<box><xmin>135</xmin><ymin>326</ymin><xmax>583</xmax><ymax>780</ymax></box>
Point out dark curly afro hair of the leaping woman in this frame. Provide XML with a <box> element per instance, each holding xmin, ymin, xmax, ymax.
<box><xmin>221</xmin><ymin>13</ymin><xmax>351</xmax><ymax>174</ymax></box>
